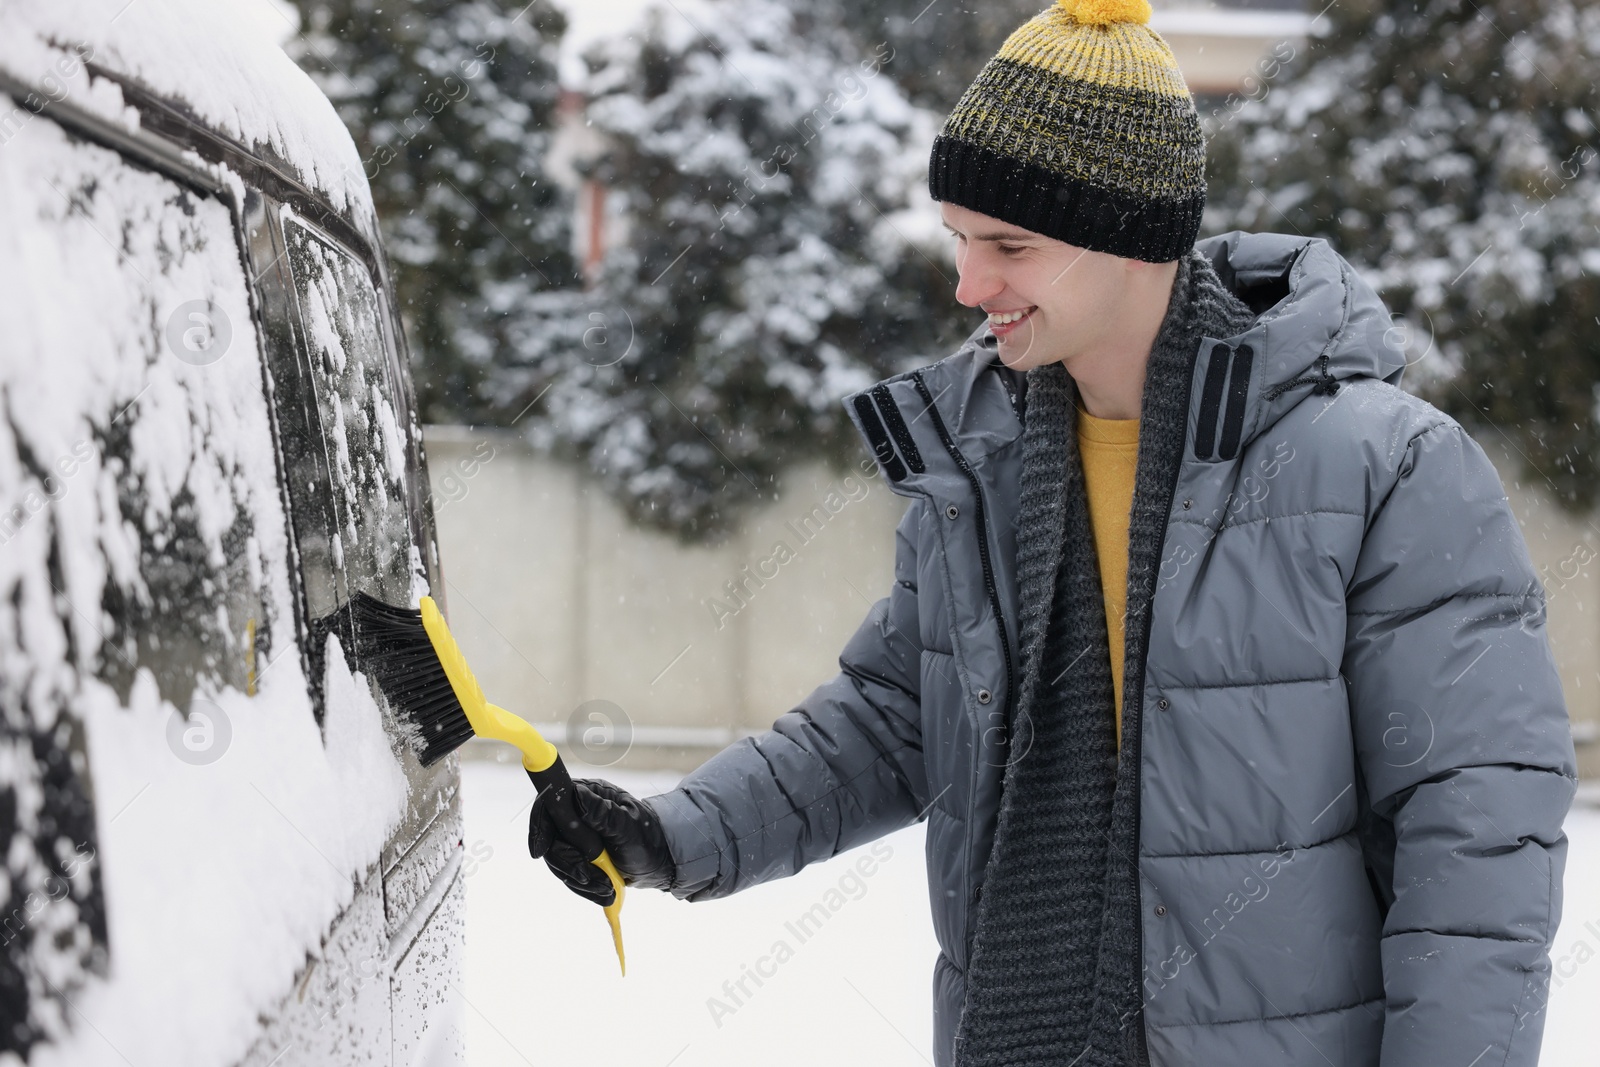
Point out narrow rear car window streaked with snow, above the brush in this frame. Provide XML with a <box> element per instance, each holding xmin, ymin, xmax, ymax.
<box><xmin>283</xmin><ymin>218</ymin><xmax>413</xmax><ymax>607</ymax></box>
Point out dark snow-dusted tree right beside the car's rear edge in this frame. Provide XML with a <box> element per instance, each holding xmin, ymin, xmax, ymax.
<box><xmin>290</xmin><ymin>0</ymin><xmax>578</xmax><ymax>422</ymax></box>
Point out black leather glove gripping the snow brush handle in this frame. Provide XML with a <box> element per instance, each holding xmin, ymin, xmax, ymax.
<box><xmin>528</xmin><ymin>779</ymin><xmax>677</xmax><ymax>907</ymax></box>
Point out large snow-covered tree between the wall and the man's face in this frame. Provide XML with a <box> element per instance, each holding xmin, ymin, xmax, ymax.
<box><xmin>494</xmin><ymin>0</ymin><xmax>978</xmax><ymax>537</ymax></box>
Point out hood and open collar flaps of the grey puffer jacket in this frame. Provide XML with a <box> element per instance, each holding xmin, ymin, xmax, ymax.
<box><xmin>845</xmin><ymin>230</ymin><xmax>1405</xmax><ymax>488</ymax></box>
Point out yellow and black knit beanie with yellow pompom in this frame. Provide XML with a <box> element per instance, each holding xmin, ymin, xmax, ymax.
<box><xmin>928</xmin><ymin>0</ymin><xmax>1205</xmax><ymax>262</ymax></box>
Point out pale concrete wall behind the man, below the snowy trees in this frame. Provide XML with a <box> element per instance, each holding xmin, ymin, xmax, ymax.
<box><xmin>427</xmin><ymin>427</ymin><xmax>1600</xmax><ymax>776</ymax></box>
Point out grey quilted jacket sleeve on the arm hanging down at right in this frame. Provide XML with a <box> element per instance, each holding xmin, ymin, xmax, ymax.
<box><xmin>1344</xmin><ymin>421</ymin><xmax>1576</xmax><ymax>1067</ymax></box>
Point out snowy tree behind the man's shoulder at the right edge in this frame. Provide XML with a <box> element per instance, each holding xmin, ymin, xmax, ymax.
<box><xmin>1206</xmin><ymin>0</ymin><xmax>1600</xmax><ymax>509</ymax></box>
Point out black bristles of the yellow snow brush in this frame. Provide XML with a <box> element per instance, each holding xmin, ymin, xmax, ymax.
<box><xmin>339</xmin><ymin>593</ymin><xmax>472</xmax><ymax>766</ymax></box>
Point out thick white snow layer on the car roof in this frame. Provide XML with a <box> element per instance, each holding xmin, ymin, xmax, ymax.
<box><xmin>0</xmin><ymin>0</ymin><xmax>376</xmax><ymax>235</ymax></box>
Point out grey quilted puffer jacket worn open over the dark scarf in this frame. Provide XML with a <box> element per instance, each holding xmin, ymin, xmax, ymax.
<box><xmin>651</xmin><ymin>234</ymin><xmax>1576</xmax><ymax>1067</ymax></box>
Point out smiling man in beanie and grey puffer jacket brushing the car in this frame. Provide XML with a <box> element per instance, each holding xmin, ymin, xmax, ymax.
<box><xmin>530</xmin><ymin>0</ymin><xmax>1576</xmax><ymax>1067</ymax></box>
